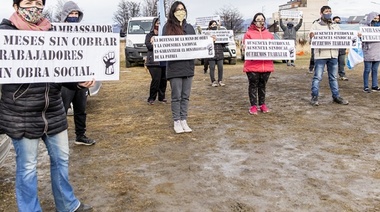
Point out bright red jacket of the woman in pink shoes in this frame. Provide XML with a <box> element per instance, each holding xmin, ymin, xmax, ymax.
<box><xmin>243</xmin><ymin>24</ymin><xmax>274</xmax><ymax>72</ymax></box>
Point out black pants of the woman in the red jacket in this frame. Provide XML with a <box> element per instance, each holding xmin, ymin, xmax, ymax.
<box><xmin>247</xmin><ymin>72</ymin><xmax>271</xmax><ymax>106</ymax></box>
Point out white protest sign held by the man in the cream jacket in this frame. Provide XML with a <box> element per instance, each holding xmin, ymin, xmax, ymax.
<box><xmin>310</xmin><ymin>30</ymin><xmax>358</xmax><ymax>49</ymax></box>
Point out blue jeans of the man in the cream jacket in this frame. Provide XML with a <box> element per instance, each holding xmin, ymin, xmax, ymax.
<box><xmin>311</xmin><ymin>58</ymin><xmax>339</xmax><ymax>98</ymax></box>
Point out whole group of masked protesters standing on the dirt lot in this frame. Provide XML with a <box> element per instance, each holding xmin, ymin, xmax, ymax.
<box><xmin>0</xmin><ymin>0</ymin><xmax>380</xmax><ymax>212</ymax></box>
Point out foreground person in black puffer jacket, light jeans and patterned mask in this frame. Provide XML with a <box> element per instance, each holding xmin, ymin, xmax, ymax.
<box><xmin>0</xmin><ymin>0</ymin><xmax>94</xmax><ymax>212</ymax></box>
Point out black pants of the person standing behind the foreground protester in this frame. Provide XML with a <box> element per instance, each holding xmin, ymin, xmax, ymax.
<box><xmin>61</xmin><ymin>87</ymin><xmax>88</xmax><ymax>137</ymax></box>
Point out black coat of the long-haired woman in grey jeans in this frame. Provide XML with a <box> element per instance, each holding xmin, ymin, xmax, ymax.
<box><xmin>163</xmin><ymin>20</ymin><xmax>195</xmax><ymax>79</ymax></box>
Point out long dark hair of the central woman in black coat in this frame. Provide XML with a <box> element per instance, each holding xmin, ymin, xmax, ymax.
<box><xmin>165</xmin><ymin>1</ymin><xmax>187</xmax><ymax>35</ymax></box>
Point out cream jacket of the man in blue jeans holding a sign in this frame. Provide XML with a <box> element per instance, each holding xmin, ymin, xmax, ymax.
<box><xmin>310</xmin><ymin>19</ymin><xmax>340</xmax><ymax>60</ymax></box>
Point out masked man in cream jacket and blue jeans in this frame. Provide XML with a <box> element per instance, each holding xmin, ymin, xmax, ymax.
<box><xmin>309</xmin><ymin>6</ymin><xmax>348</xmax><ymax>106</ymax></box>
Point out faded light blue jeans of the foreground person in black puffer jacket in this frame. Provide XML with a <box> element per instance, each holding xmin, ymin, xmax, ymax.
<box><xmin>12</xmin><ymin>130</ymin><xmax>80</xmax><ymax>212</ymax></box>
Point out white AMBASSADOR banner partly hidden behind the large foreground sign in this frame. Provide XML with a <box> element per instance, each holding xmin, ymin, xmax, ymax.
<box><xmin>52</xmin><ymin>23</ymin><xmax>113</xmax><ymax>33</ymax></box>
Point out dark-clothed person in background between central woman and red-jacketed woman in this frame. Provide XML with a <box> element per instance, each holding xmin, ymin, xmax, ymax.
<box><xmin>207</xmin><ymin>20</ymin><xmax>226</xmax><ymax>87</ymax></box>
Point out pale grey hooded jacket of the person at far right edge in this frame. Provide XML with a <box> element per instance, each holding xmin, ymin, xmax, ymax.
<box><xmin>362</xmin><ymin>12</ymin><xmax>380</xmax><ymax>62</ymax></box>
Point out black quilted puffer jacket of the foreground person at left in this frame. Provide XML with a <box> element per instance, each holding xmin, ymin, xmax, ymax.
<box><xmin>0</xmin><ymin>19</ymin><xmax>79</xmax><ymax>139</ymax></box>
